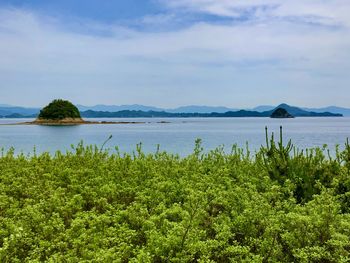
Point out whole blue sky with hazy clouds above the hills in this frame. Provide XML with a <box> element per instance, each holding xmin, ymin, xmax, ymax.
<box><xmin>0</xmin><ymin>0</ymin><xmax>350</xmax><ymax>108</ymax></box>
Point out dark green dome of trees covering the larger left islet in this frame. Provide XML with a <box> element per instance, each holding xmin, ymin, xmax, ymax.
<box><xmin>38</xmin><ymin>99</ymin><xmax>81</xmax><ymax>120</ymax></box>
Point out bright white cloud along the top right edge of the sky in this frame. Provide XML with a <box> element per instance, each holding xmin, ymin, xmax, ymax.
<box><xmin>163</xmin><ymin>0</ymin><xmax>350</xmax><ymax>26</ymax></box>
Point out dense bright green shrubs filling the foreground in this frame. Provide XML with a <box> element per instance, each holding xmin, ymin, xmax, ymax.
<box><xmin>0</xmin><ymin>131</ymin><xmax>350</xmax><ymax>262</ymax></box>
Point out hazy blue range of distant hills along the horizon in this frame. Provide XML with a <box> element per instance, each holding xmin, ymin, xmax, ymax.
<box><xmin>0</xmin><ymin>103</ymin><xmax>344</xmax><ymax>118</ymax></box>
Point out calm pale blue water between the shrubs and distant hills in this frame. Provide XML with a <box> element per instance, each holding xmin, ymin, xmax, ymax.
<box><xmin>0</xmin><ymin>118</ymin><xmax>350</xmax><ymax>155</ymax></box>
